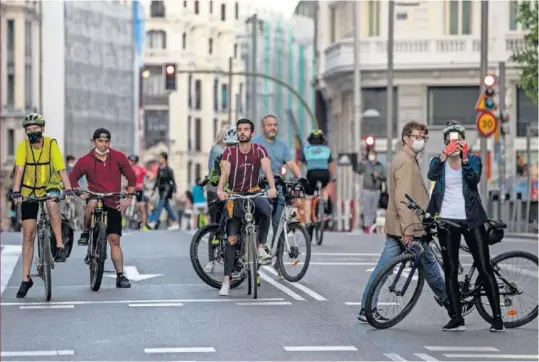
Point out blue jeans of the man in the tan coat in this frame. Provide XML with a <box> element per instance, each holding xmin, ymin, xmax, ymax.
<box><xmin>361</xmin><ymin>235</ymin><xmax>447</xmax><ymax>309</ymax></box>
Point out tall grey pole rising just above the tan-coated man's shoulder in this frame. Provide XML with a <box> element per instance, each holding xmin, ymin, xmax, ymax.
<box><xmin>386</xmin><ymin>0</ymin><xmax>395</xmax><ymax>169</ymax></box>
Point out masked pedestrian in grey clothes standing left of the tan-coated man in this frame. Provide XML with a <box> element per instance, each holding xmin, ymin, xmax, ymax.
<box><xmin>356</xmin><ymin>150</ymin><xmax>387</xmax><ymax>233</ymax></box>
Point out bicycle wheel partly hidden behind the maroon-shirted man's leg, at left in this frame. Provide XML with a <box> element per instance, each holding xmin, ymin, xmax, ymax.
<box><xmin>189</xmin><ymin>224</ymin><xmax>245</xmax><ymax>289</ymax></box>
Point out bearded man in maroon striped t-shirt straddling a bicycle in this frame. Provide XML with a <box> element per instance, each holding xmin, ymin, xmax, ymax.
<box><xmin>217</xmin><ymin>118</ymin><xmax>277</xmax><ymax>295</ymax></box>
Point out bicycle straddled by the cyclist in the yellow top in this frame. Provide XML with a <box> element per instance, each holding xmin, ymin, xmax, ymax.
<box><xmin>23</xmin><ymin>194</ymin><xmax>65</xmax><ymax>302</ymax></box>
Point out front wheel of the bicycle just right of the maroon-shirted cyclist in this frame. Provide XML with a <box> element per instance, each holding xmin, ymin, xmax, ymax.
<box><xmin>277</xmin><ymin>222</ymin><xmax>311</xmax><ymax>283</ymax></box>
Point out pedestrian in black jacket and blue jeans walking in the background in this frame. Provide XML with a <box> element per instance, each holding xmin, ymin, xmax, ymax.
<box><xmin>148</xmin><ymin>152</ymin><xmax>180</xmax><ymax>230</ymax></box>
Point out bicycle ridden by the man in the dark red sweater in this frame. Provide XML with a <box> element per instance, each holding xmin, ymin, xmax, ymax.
<box><xmin>79</xmin><ymin>191</ymin><xmax>126</xmax><ymax>292</ymax></box>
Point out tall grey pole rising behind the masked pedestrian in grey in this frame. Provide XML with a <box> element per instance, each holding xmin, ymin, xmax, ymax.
<box><xmin>349</xmin><ymin>1</ymin><xmax>363</xmax><ymax>229</ymax></box>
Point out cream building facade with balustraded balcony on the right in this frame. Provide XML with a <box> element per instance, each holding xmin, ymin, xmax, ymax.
<box><xmin>317</xmin><ymin>0</ymin><xmax>538</xmax><ymax>222</ymax></box>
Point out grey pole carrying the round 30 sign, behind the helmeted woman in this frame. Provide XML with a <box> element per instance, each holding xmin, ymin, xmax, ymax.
<box><xmin>479</xmin><ymin>0</ymin><xmax>489</xmax><ymax>208</ymax></box>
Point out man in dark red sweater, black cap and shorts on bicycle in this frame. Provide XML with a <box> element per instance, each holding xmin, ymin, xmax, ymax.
<box><xmin>69</xmin><ymin>128</ymin><xmax>136</xmax><ymax>288</ymax></box>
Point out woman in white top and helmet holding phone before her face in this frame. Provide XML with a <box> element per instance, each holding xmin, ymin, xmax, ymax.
<box><xmin>427</xmin><ymin>121</ymin><xmax>504</xmax><ymax>332</ymax></box>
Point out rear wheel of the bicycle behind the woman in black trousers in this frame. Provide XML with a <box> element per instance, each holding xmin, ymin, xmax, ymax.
<box><xmin>475</xmin><ymin>251</ymin><xmax>537</xmax><ymax>328</ymax></box>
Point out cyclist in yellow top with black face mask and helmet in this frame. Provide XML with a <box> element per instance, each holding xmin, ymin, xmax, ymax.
<box><xmin>12</xmin><ymin>113</ymin><xmax>73</xmax><ymax>298</ymax></box>
